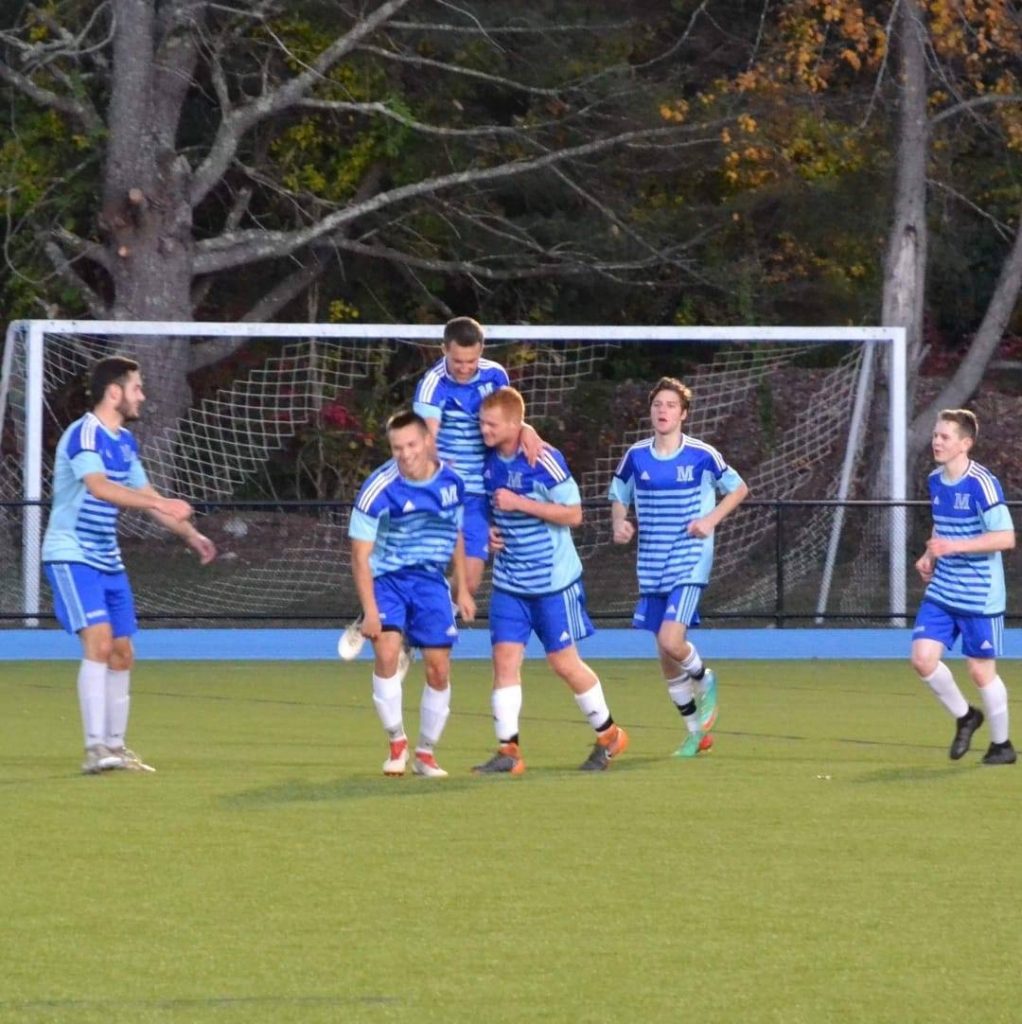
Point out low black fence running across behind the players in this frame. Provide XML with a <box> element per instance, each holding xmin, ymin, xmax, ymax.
<box><xmin>6</xmin><ymin>499</ymin><xmax>1022</xmax><ymax>629</ymax></box>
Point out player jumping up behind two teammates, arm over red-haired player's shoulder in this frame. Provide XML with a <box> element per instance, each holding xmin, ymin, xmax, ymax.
<box><xmin>413</xmin><ymin>316</ymin><xmax>543</xmax><ymax>595</ymax></box>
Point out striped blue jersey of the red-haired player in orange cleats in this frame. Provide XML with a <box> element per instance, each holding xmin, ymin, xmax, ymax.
<box><xmin>482</xmin><ymin>445</ymin><xmax>582</xmax><ymax>596</ymax></box>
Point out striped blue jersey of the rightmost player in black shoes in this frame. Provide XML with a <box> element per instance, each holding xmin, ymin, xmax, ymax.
<box><xmin>924</xmin><ymin>462</ymin><xmax>1015</xmax><ymax>615</ymax></box>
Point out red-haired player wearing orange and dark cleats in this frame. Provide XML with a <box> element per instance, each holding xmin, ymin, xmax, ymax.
<box><xmin>475</xmin><ymin>387</ymin><xmax>628</xmax><ymax>775</ymax></box>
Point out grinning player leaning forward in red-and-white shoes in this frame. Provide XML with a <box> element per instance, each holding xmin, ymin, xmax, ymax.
<box><xmin>348</xmin><ymin>412</ymin><xmax>475</xmax><ymax>778</ymax></box>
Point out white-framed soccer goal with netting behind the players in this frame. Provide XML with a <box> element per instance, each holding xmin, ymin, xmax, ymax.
<box><xmin>0</xmin><ymin>321</ymin><xmax>907</xmax><ymax>625</ymax></box>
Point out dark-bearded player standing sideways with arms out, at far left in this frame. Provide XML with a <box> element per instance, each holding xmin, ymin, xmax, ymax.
<box><xmin>42</xmin><ymin>355</ymin><xmax>216</xmax><ymax>775</ymax></box>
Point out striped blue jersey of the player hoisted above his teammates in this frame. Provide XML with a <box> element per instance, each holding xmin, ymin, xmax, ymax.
<box><xmin>412</xmin><ymin>358</ymin><xmax>509</xmax><ymax>495</ymax></box>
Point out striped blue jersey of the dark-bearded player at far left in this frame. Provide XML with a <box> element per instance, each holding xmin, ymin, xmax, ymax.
<box><xmin>43</xmin><ymin>413</ymin><xmax>148</xmax><ymax>572</ymax></box>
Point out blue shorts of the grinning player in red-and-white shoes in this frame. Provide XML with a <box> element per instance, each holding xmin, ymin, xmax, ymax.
<box><xmin>373</xmin><ymin>568</ymin><xmax>458</xmax><ymax>647</ymax></box>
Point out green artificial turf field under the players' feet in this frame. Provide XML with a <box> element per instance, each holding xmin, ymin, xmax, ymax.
<box><xmin>0</xmin><ymin>662</ymin><xmax>1022</xmax><ymax>1024</ymax></box>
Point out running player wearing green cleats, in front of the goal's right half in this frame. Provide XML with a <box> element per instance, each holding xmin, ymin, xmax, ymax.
<box><xmin>609</xmin><ymin>377</ymin><xmax>749</xmax><ymax>758</ymax></box>
